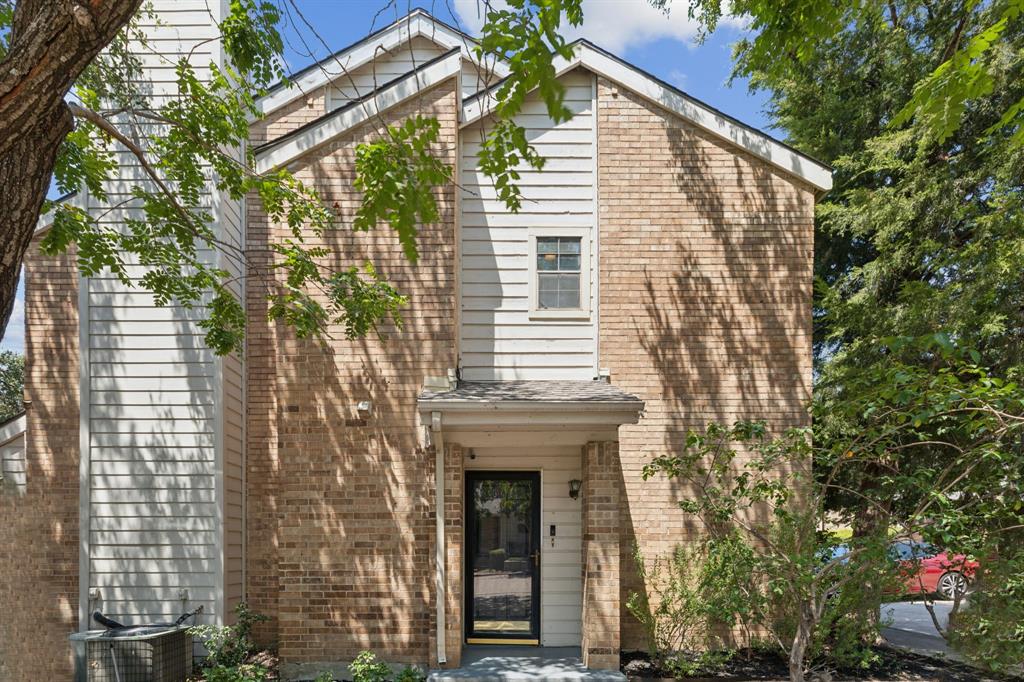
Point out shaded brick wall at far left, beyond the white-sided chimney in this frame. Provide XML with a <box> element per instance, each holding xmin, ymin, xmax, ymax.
<box><xmin>0</xmin><ymin>238</ymin><xmax>79</xmax><ymax>681</ymax></box>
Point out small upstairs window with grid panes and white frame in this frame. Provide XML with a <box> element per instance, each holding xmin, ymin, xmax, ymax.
<box><xmin>529</xmin><ymin>227</ymin><xmax>591</xmax><ymax>318</ymax></box>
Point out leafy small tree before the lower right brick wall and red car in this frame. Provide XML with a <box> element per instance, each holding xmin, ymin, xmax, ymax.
<box><xmin>644</xmin><ymin>336</ymin><xmax>1024</xmax><ymax>680</ymax></box>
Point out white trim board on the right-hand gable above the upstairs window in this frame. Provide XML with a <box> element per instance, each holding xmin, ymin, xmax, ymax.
<box><xmin>462</xmin><ymin>40</ymin><xmax>833</xmax><ymax>190</ymax></box>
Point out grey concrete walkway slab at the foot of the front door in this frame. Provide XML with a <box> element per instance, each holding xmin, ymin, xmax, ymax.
<box><xmin>427</xmin><ymin>645</ymin><xmax>626</xmax><ymax>682</ymax></box>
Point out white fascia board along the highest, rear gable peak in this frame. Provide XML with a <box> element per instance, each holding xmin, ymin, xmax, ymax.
<box><xmin>250</xmin><ymin>9</ymin><xmax>508</xmax><ymax>118</ymax></box>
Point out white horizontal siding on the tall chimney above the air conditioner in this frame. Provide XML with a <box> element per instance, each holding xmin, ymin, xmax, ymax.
<box><xmin>80</xmin><ymin>0</ymin><xmax>234</xmax><ymax>625</ymax></box>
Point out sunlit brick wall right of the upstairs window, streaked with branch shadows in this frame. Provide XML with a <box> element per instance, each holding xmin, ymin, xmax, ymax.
<box><xmin>598</xmin><ymin>80</ymin><xmax>814</xmax><ymax>650</ymax></box>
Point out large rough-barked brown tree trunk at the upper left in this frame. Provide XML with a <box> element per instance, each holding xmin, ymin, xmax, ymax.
<box><xmin>0</xmin><ymin>0</ymin><xmax>142</xmax><ymax>338</ymax></box>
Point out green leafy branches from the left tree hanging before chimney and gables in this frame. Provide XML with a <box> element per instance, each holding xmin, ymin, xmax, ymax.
<box><xmin>0</xmin><ymin>0</ymin><xmax>582</xmax><ymax>353</ymax></box>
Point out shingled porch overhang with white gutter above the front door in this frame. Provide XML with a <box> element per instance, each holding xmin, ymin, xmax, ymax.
<box><xmin>418</xmin><ymin>381</ymin><xmax>644</xmax><ymax>433</ymax></box>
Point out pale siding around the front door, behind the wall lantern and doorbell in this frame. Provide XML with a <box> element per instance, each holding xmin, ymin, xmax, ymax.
<box><xmin>464</xmin><ymin>445</ymin><xmax>583</xmax><ymax>646</ymax></box>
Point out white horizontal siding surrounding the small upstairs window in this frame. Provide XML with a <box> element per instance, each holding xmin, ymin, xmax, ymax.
<box><xmin>460</xmin><ymin>71</ymin><xmax>597</xmax><ymax>381</ymax></box>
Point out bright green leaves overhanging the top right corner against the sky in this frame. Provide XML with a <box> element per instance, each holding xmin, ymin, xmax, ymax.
<box><xmin>688</xmin><ymin>0</ymin><xmax>1024</xmax><ymax>147</ymax></box>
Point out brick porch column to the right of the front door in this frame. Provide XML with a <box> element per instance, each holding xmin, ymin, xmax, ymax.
<box><xmin>582</xmin><ymin>440</ymin><xmax>622</xmax><ymax>670</ymax></box>
